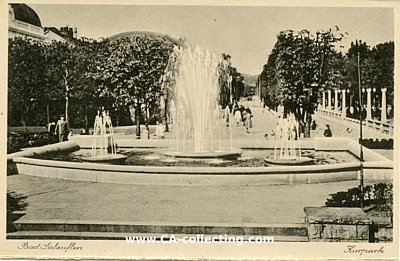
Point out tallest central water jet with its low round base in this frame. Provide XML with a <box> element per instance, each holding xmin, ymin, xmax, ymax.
<box><xmin>162</xmin><ymin>47</ymin><xmax>241</xmax><ymax>159</ymax></box>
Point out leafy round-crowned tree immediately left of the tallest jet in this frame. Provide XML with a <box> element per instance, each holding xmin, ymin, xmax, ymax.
<box><xmin>95</xmin><ymin>34</ymin><xmax>173</xmax><ymax>137</ymax></box>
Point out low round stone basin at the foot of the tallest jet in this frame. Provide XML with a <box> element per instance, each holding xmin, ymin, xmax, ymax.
<box><xmin>159</xmin><ymin>149</ymin><xmax>242</xmax><ymax>159</ymax></box>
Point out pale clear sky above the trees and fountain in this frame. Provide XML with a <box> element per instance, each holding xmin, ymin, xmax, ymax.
<box><xmin>29</xmin><ymin>4</ymin><xmax>394</xmax><ymax>75</ymax></box>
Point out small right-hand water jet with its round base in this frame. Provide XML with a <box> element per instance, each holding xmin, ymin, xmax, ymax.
<box><xmin>264</xmin><ymin>113</ymin><xmax>313</xmax><ymax>165</ymax></box>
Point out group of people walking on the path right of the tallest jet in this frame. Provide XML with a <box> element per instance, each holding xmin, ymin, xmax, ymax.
<box><xmin>224</xmin><ymin>102</ymin><xmax>253</xmax><ymax>133</ymax></box>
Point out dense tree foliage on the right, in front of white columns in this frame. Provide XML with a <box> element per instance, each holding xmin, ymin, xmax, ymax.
<box><xmin>259</xmin><ymin>27</ymin><xmax>394</xmax><ymax>137</ymax></box>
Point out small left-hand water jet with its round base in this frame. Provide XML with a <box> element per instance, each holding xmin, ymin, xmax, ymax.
<box><xmin>82</xmin><ymin>107</ymin><xmax>127</xmax><ymax>164</ymax></box>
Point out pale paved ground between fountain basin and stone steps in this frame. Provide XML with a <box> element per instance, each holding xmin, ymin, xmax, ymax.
<box><xmin>7</xmin><ymin>175</ymin><xmax>366</xmax><ymax>224</ymax></box>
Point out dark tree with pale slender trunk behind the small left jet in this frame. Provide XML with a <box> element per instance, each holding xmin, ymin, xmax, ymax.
<box><xmin>44</xmin><ymin>39</ymin><xmax>100</xmax><ymax>128</ymax></box>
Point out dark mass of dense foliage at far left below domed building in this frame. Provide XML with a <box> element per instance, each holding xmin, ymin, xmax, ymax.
<box><xmin>8</xmin><ymin>38</ymin><xmax>107</xmax><ymax>128</ymax></box>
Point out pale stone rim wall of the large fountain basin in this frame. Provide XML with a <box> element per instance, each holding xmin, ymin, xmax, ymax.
<box><xmin>8</xmin><ymin>137</ymin><xmax>393</xmax><ymax>186</ymax></box>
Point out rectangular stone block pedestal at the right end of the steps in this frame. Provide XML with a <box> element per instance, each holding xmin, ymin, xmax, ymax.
<box><xmin>304</xmin><ymin>207</ymin><xmax>372</xmax><ymax>242</ymax></box>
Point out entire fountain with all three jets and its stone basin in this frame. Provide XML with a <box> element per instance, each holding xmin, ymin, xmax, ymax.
<box><xmin>7</xmin><ymin>31</ymin><xmax>393</xmax><ymax>187</ymax></box>
